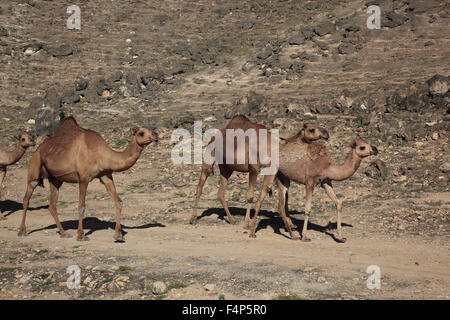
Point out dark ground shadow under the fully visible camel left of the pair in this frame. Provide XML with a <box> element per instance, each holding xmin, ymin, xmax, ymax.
<box><xmin>28</xmin><ymin>217</ymin><xmax>165</xmax><ymax>236</ymax></box>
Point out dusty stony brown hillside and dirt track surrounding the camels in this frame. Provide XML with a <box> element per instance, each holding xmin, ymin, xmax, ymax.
<box><xmin>0</xmin><ymin>0</ymin><xmax>450</xmax><ymax>299</ymax></box>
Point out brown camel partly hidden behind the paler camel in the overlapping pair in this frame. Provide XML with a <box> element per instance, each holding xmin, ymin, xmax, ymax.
<box><xmin>189</xmin><ymin>115</ymin><xmax>329</xmax><ymax>229</ymax></box>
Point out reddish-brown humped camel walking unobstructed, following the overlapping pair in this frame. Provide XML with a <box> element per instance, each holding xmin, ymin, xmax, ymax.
<box><xmin>18</xmin><ymin>117</ymin><xmax>157</xmax><ymax>241</ymax></box>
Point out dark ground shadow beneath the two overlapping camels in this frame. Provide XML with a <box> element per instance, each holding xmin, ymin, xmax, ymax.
<box><xmin>197</xmin><ymin>207</ymin><xmax>353</xmax><ymax>242</ymax></box>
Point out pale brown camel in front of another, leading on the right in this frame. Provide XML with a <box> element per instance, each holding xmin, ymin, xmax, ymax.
<box><xmin>250</xmin><ymin>140</ymin><xmax>378</xmax><ymax>242</ymax></box>
